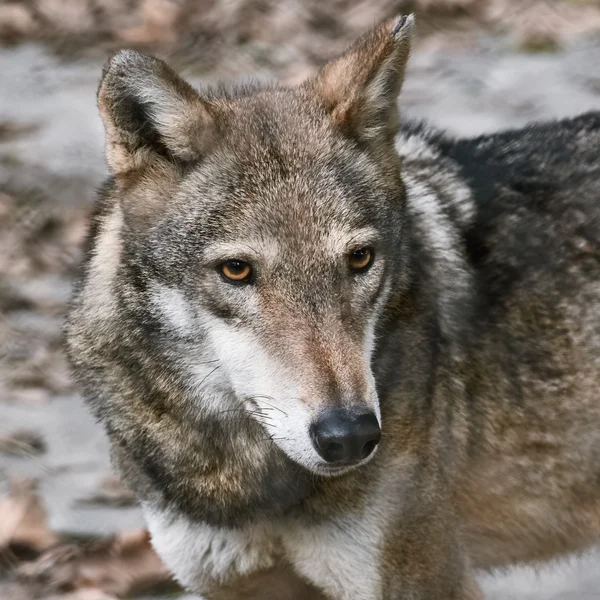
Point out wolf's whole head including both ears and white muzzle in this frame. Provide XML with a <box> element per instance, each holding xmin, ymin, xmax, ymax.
<box><xmin>84</xmin><ymin>16</ymin><xmax>413</xmax><ymax>475</ymax></box>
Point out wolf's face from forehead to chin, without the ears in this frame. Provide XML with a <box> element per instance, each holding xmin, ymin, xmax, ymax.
<box><xmin>143</xmin><ymin>111</ymin><xmax>408</xmax><ymax>472</ymax></box>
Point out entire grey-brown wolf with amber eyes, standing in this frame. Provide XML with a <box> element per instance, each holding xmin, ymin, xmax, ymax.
<box><xmin>67</xmin><ymin>16</ymin><xmax>600</xmax><ymax>600</ymax></box>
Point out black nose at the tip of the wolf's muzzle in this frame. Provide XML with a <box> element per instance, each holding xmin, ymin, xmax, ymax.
<box><xmin>310</xmin><ymin>408</ymin><xmax>381</xmax><ymax>463</ymax></box>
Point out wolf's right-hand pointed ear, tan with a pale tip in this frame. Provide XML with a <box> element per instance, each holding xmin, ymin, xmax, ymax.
<box><xmin>308</xmin><ymin>15</ymin><xmax>414</xmax><ymax>148</ymax></box>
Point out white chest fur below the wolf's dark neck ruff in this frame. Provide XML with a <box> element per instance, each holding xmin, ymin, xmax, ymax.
<box><xmin>144</xmin><ymin>507</ymin><xmax>380</xmax><ymax>600</ymax></box>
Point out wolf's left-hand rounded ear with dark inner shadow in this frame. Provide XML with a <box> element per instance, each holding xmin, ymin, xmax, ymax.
<box><xmin>98</xmin><ymin>50</ymin><xmax>215</xmax><ymax>173</ymax></box>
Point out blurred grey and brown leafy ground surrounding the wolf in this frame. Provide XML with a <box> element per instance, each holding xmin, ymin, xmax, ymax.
<box><xmin>0</xmin><ymin>0</ymin><xmax>600</xmax><ymax>600</ymax></box>
